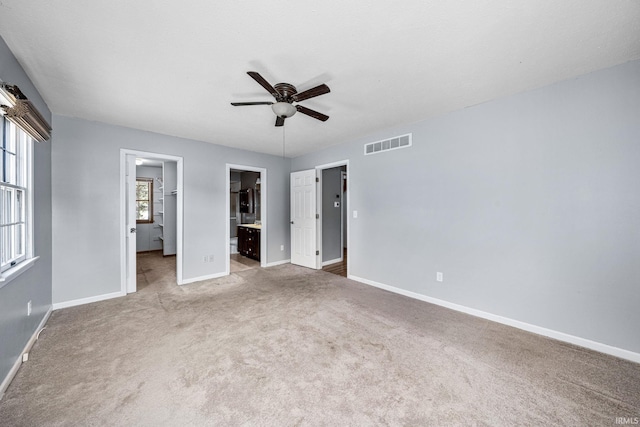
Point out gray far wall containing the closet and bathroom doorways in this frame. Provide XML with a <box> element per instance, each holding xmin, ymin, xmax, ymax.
<box><xmin>52</xmin><ymin>115</ymin><xmax>290</xmax><ymax>303</ymax></box>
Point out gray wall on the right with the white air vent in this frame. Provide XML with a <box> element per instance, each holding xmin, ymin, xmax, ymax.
<box><xmin>292</xmin><ymin>61</ymin><xmax>640</xmax><ymax>352</ymax></box>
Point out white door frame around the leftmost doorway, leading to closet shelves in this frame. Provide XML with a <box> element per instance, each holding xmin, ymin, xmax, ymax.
<box><xmin>120</xmin><ymin>148</ymin><xmax>184</xmax><ymax>295</ymax></box>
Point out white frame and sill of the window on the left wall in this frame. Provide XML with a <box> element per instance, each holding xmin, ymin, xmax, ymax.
<box><xmin>0</xmin><ymin>116</ymin><xmax>39</xmax><ymax>288</ymax></box>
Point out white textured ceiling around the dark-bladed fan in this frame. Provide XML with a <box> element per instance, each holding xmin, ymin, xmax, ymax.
<box><xmin>0</xmin><ymin>0</ymin><xmax>640</xmax><ymax>157</ymax></box>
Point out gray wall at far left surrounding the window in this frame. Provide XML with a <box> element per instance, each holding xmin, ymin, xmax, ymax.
<box><xmin>0</xmin><ymin>38</ymin><xmax>55</xmax><ymax>382</ymax></box>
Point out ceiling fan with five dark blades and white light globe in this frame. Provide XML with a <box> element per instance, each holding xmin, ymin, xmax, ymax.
<box><xmin>231</xmin><ymin>71</ymin><xmax>331</xmax><ymax>126</ymax></box>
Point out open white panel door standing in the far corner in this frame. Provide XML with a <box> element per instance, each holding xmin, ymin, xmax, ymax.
<box><xmin>291</xmin><ymin>169</ymin><xmax>318</xmax><ymax>269</ymax></box>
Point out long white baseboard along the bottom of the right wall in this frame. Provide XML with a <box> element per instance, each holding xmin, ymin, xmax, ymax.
<box><xmin>349</xmin><ymin>275</ymin><xmax>640</xmax><ymax>363</ymax></box>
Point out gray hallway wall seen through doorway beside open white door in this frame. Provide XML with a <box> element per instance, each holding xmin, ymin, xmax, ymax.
<box><xmin>320</xmin><ymin>167</ymin><xmax>342</xmax><ymax>262</ymax></box>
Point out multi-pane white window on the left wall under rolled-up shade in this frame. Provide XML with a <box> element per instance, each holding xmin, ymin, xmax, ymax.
<box><xmin>0</xmin><ymin>117</ymin><xmax>33</xmax><ymax>281</ymax></box>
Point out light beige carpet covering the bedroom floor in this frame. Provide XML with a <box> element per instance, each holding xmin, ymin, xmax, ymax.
<box><xmin>0</xmin><ymin>254</ymin><xmax>640</xmax><ymax>426</ymax></box>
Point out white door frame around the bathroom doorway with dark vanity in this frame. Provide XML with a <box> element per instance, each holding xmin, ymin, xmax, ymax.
<box><xmin>224</xmin><ymin>163</ymin><xmax>268</xmax><ymax>276</ymax></box>
